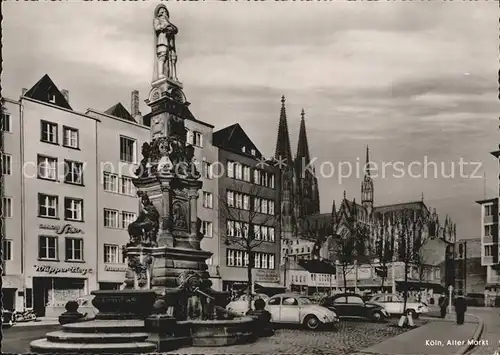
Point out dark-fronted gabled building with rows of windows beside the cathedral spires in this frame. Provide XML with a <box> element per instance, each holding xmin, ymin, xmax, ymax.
<box><xmin>211</xmin><ymin>124</ymin><xmax>281</xmax><ymax>290</ymax></box>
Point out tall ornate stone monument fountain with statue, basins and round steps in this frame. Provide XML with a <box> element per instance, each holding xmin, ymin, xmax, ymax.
<box><xmin>30</xmin><ymin>4</ymin><xmax>255</xmax><ymax>353</ymax></box>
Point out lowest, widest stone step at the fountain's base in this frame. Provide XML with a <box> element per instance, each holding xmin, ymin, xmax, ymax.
<box><xmin>30</xmin><ymin>338</ymin><xmax>156</xmax><ymax>354</ymax></box>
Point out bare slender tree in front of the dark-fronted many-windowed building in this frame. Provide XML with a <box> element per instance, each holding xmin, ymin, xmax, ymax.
<box><xmin>218</xmin><ymin>181</ymin><xmax>279</xmax><ymax>306</ymax></box>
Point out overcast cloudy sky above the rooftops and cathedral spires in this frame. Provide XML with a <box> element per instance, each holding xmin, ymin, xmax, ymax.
<box><xmin>2</xmin><ymin>1</ymin><xmax>499</xmax><ymax>238</ymax></box>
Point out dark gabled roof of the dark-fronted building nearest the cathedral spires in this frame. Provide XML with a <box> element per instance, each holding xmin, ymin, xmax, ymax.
<box><xmin>213</xmin><ymin>123</ymin><xmax>262</xmax><ymax>158</ymax></box>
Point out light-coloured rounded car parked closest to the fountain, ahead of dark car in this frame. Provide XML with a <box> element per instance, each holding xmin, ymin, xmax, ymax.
<box><xmin>266</xmin><ymin>293</ymin><xmax>339</xmax><ymax>330</ymax></box>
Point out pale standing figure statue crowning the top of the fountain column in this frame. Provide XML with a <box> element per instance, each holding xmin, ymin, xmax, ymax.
<box><xmin>153</xmin><ymin>4</ymin><xmax>179</xmax><ymax>81</ymax></box>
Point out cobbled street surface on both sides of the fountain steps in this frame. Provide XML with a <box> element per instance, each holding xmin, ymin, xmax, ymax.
<box><xmin>2</xmin><ymin>320</ymin><xmax>422</xmax><ymax>355</ymax></box>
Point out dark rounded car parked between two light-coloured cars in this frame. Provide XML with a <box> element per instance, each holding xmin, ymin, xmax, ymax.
<box><xmin>321</xmin><ymin>293</ymin><xmax>389</xmax><ymax>322</ymax></box>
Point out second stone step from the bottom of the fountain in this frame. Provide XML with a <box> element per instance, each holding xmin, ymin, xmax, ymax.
<box><xmin>46</xmin><ymin>330</ymin><xmax>149</xmax><ymax>344</ymax></box>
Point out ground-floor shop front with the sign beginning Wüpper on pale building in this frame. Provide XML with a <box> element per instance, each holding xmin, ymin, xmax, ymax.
<box><xmin>30</xmin><ymin>264</ymin><xmax>94</xmax><ymax>317</ymax></box>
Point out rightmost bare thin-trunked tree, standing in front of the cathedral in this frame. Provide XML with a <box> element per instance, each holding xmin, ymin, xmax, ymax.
<box><xmin>397</xmin><ymin>209</ymin><xmax>428</xmax><ymax>324</ymax></box>
